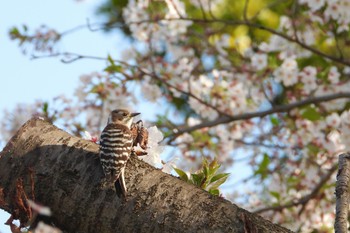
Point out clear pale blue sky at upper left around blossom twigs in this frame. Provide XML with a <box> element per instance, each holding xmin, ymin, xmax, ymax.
<box><xmin>0</xmin><ymin>0</ymin><xmax>123</xmax><ymax>233</ymax></box>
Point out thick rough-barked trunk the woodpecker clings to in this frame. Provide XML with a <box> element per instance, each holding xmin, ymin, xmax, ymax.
<box><xmin>0</xmin><ymin>119</ymin><xmax>291</xmax><ymax>233</ymax></box>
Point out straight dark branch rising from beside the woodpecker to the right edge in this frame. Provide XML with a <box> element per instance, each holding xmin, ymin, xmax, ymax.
<box><xmin>169</xmin><ymin>92</ymin><xmax>350</xmax><ymax>142</ymax></box>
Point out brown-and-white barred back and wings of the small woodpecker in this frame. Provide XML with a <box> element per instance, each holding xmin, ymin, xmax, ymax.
<box><xmin>100</xmin><ymin>123</ymin><xmax>133</xmax><ymax>183</ymax></box>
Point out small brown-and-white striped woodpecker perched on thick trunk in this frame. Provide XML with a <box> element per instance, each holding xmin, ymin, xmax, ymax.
<box><xmin>99</xmin><ymin>109</ymin><xmax>140</xmax><ymax>197</ymax></box>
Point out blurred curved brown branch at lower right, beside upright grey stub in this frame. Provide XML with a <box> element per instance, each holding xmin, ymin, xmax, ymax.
<box><xmin>253</xmin><ymin>164</ymin><xmax>338</xmax><ymax>214</ymax></box>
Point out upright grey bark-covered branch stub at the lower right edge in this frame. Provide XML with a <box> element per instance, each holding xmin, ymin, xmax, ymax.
<box><xmin>334</xmin><ymin>153</ymin><xmax>350</xmax><ymax>233</ymax></box>
